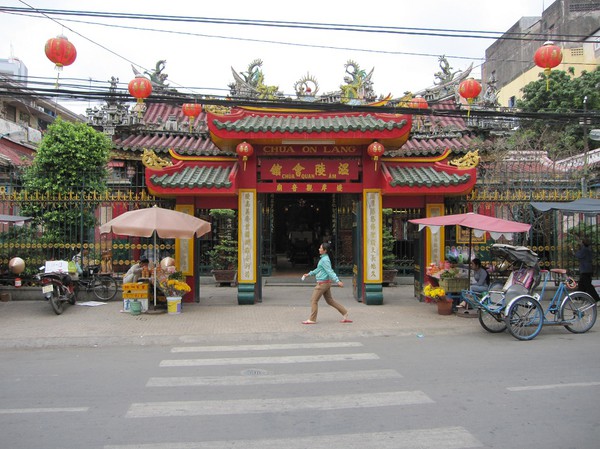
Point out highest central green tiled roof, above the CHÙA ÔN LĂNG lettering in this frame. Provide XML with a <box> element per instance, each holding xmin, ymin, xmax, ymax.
<box><xmin>213</xmin><ymin>115</ymin><xmax>406</xmax><ymax>133</ymax></box>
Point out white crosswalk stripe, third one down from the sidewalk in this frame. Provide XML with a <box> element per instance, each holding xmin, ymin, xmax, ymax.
<box><xmin>146</xmin><ymin>369</ymin><xmax>402</xmax><ymax>387</ymax></box>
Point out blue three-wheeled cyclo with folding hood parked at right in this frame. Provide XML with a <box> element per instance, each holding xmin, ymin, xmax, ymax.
<box><xmin>461</xmin><ymin>243</ymin><xmax>597</xmax><ymax>340</ymax></box>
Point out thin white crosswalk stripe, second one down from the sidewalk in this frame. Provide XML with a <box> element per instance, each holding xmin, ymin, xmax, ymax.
<box><xmin>160</xmin><ymin>353</ymin><xmax>379</xmax><ymax>367</ymax></box>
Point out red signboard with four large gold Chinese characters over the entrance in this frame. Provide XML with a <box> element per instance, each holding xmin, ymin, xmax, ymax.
<box><xmin>260</xmin><ymin>159</ymin><xmax>359</xmax><ymax>181</ymax></box>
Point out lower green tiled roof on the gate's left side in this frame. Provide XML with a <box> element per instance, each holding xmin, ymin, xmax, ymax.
<box><xmin>150</xmin><ymin>164</ymin><xmax>233</xmax><ymax>189</ymax></box>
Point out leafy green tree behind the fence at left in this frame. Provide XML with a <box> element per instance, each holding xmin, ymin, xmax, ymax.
<box><xmin>23</xmin><ymin>118</ymin><xmax>112</xmax><ymax>252</ymax></box>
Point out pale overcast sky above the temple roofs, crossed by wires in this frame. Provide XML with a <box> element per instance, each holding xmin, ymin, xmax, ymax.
<box><xmin>0</xmin><ymin>0</ymin><xmax>552</xmax><ymax>113</ymax></box>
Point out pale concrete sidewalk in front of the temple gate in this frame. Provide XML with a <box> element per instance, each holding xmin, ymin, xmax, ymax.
<box><xmin>0</xmin><ymin>279</ymin><xmax>481</xmax><ymax>348</ymax></box>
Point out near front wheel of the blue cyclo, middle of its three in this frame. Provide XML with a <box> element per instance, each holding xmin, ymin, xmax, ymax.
<box><xmin>505</xmin><ymin>296</ymin><xmax>544</xmax><ymax>340</ymax></box>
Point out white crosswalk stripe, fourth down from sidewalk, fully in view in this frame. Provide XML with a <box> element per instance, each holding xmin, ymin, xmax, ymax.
<box><xmin>126</xmin><ymin>391</ymin><xmax>434</xmax><ymax>418</ymax></box>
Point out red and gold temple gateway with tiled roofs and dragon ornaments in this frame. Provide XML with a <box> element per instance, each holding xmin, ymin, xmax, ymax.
<box><xmin>91</xmin><ymin>61</ymin><xmax>488</xmax><ymax>305</ymax></box>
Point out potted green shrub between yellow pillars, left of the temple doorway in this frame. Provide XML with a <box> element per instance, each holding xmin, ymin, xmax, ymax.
<box><xmin>207</xmin><ymin>209</ymin><xmax>238</xmax><ymax>285</ymax></box>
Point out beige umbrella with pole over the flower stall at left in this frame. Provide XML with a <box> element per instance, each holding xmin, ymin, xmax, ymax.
<box><xmin>100</xmin><ymin>206</ymin><xmax>210</xmax><ymax>306</ymax></box>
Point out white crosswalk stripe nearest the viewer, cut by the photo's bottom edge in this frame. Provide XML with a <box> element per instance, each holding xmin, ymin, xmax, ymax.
<box><xmin>104</xmin><ymin>426</ymin><xmax>483</xmax><ymax>449</ymax></box>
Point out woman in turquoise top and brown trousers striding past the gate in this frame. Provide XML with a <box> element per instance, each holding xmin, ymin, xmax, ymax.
<box><xmin>302</xmin><ymin>243</ymin><xmax>352</xmax><ymax>324</ymax></box>
